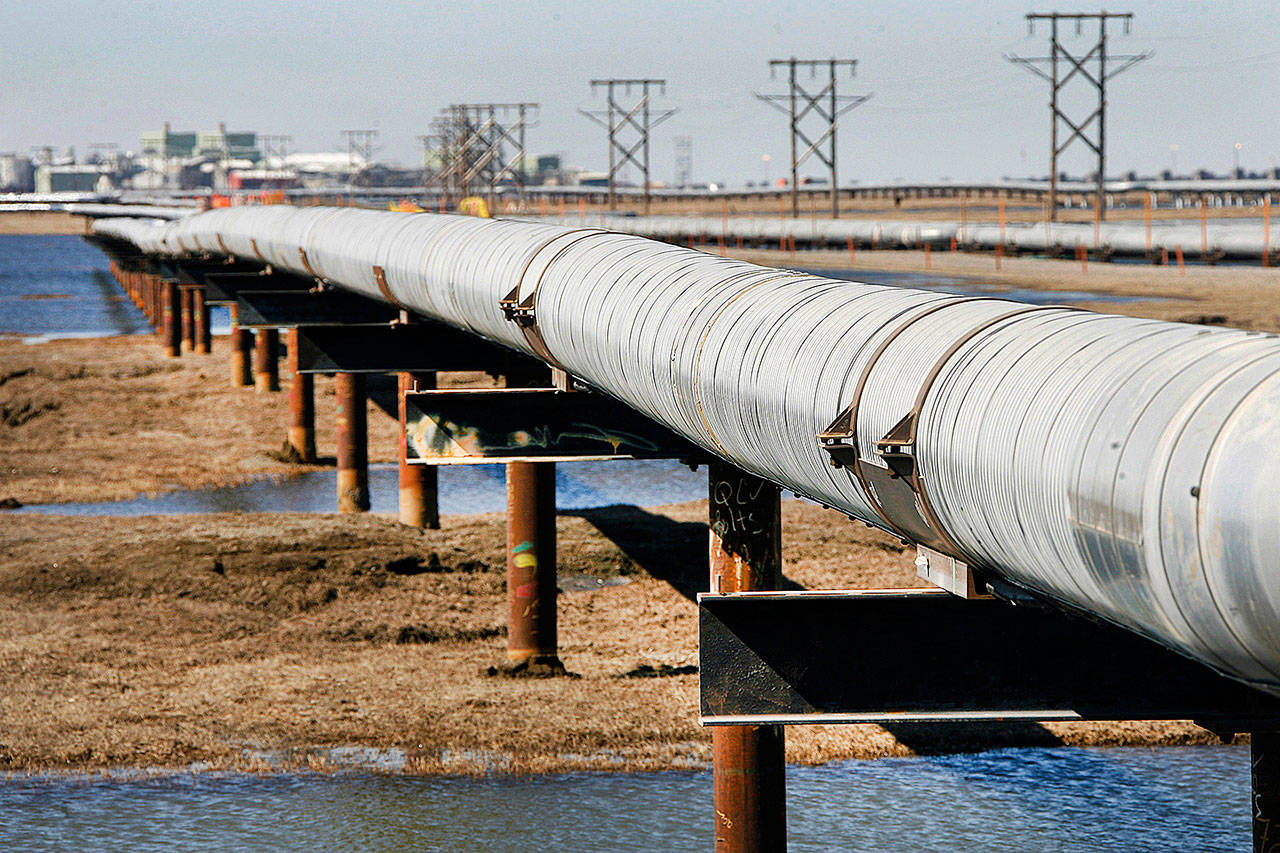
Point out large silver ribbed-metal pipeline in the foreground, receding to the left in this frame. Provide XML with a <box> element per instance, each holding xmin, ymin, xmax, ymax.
<box><xmin>95</xmin><ymin>206</ymin><xmax>1280</xmax><ymax>694</ymax></box>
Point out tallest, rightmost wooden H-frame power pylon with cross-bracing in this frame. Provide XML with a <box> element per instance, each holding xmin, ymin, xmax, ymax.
<box><xmin>1005</xmin><ymin>12</ymin><xmax>1152</xmax><ymax>219</ymax></box>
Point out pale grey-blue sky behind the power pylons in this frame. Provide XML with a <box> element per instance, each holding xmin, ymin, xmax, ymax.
<box><xmin>0</xmin><ymin>0</ymin><xmax>1280</xmax><ymax>184</ymax></box>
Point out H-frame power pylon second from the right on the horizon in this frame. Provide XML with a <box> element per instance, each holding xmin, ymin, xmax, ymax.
<box><xmin>755</xmin><ymin>56</ymin><xmax>872</xmax><ymax>218</ymax></box>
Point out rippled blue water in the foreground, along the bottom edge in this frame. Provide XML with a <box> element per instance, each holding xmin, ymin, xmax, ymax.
<box><xmin>0</xmin><ymin>747</ymin><xmax>1249</xmax><ymax>852</ymax></box>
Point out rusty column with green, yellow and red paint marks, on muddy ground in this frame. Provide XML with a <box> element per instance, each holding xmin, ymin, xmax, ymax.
<box><xmin>507</xmin><ymin>462</ymin><xmax>564</xmax><ymax>675</ymax></box>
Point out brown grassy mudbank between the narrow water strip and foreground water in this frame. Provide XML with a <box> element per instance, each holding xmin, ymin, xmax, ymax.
<box><xmin>0</xmin><ymin>502</ymin><xmax>1211</xmax><ymax>772</ymax></box>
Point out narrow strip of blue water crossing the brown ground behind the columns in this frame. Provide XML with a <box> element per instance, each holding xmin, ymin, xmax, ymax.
<box><xmin>12</xmin><ymin>460</ymin><xmax>707</xmax><ymax>515</ymax></box>
